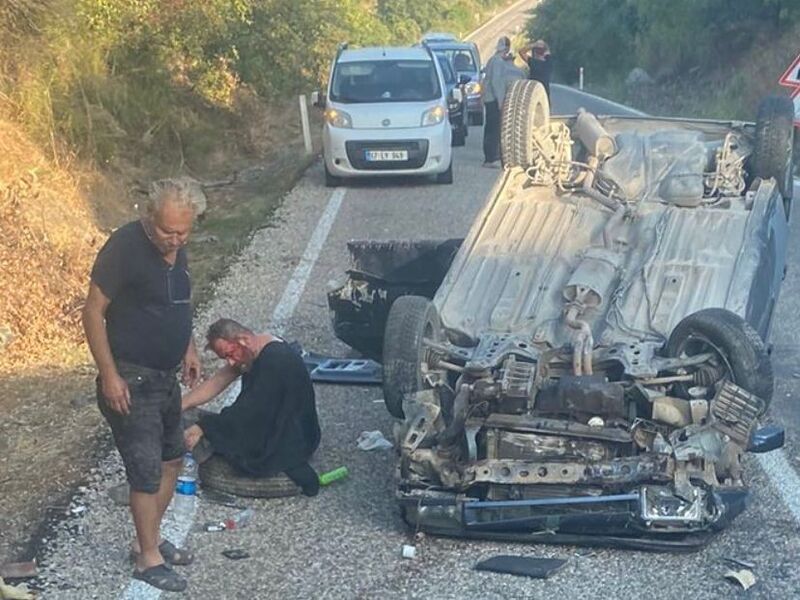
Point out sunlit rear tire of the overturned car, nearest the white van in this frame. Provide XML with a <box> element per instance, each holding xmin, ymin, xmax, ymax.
<box><xmin>500</xmin><ymin>79</ymin><xmax>550</xmax><ymax>168</ymax></box>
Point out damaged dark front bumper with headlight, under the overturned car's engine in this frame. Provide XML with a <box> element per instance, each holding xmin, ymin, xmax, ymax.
<box><xmin>398</xmin><ymin>485</ymin><xmax>748</xmax><ymax>552</ymax></box>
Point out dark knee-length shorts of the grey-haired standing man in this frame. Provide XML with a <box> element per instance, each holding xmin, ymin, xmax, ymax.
<box><xmin>97</xmin><ymin>362</ymin><xmax>186</xmax><ymax>494</ymax></box>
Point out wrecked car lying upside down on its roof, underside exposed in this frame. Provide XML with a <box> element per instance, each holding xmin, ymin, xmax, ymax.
<box><xmin>328</xmin><ymin>81</ymin><xmax>793</xmax><ymax>550</ymax></box>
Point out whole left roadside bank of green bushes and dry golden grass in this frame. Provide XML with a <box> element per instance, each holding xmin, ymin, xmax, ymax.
<box><xmin>0</xmin><ymin>0</ymin><xmax>509</xmax><ymax>372</ymax></box>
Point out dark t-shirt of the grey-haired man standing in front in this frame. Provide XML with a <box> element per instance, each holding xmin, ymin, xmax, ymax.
<box><xmin>92</xmin><ymin>221</ymin><xmax>192</xmax><ymax>371</ymax></box>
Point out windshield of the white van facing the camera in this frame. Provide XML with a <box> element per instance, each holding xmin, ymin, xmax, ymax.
<box><xmin>330</xmin><ymin>60</ymin><xmax>442</xmax><ymax>104</ymax></box>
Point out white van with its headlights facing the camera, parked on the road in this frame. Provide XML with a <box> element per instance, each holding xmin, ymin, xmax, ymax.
<box><xmin>312</xmin><ymin>46</ymin><xmax>454</xmax><ymax>187</ymax></box>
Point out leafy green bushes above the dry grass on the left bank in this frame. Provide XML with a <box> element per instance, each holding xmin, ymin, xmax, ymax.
<box><xmin>0</xmin><ymin>0</ymin><xmax>502</xmax><ymax>168</ymax></box>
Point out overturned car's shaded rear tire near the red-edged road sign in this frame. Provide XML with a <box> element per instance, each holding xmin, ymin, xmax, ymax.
<box><xmin>752</xmin><ymin>96</ymin><xmax>794</xmax><ymax>219</ymax></box>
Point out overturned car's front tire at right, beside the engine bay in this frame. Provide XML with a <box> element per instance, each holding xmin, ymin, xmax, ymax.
<box><xmin>666</xmin><ymin>308</ymin><xmax>775</xmax><ymax>406</ymax></box>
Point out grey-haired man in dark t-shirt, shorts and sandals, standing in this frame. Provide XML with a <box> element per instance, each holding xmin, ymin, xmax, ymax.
<box><xmin>83</xmin><ymin>180</ymin><xmax>200</xmax><ymax>591</ymax></box>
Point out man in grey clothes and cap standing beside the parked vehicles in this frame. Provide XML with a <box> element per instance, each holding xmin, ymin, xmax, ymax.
<box><xmin>483</xmin><ymin>36</ymin><xmax>525</xmax><ymax>169</ymax></box>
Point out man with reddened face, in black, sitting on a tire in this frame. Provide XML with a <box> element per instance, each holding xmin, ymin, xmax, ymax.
<box><xmin>182</xmin><ymin>319</ymin><xmax>320</xmax><ymax>496</ymax></box>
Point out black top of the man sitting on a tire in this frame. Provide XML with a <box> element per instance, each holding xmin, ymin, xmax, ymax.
<box><xmin>199</xmin><ymin>342</ymin><xmax>320</xmax><ymax>477</ymax></box>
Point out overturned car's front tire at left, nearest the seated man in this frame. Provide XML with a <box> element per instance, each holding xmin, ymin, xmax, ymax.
<box><xmin>383</xmin><ymin>296</ymin><xmax>441</xmax><ymax>419</ymax></box>
